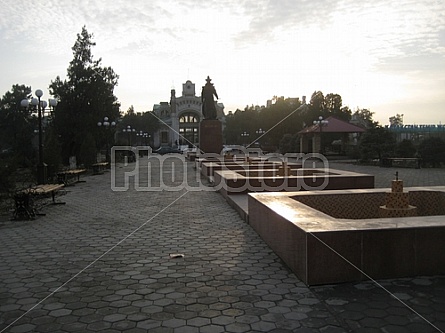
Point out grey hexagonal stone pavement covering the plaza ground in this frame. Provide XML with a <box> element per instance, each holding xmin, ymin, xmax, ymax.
<box><xmin>0</xmin><ymin>158</ymin><xmax>445</xmax><ymax>333</ymax></box>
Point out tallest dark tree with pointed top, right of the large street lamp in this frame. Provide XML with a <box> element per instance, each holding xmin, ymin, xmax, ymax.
<box><xmin>50</xmin><ymin>26</ymin><xmax>120</xmax><ymax>163</ymax></box>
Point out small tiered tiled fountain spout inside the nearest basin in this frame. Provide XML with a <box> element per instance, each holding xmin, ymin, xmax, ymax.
<box><xmin>379</xmin><ymin>172</ymin><xmax>417</xmax><ymax>218</ymax></box>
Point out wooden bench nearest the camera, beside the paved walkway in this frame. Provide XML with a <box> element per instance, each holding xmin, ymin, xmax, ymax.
<box><xmin>13</xmin><ymin>184</ymin><xmax>65</xmax><ymax>220</ymax></box>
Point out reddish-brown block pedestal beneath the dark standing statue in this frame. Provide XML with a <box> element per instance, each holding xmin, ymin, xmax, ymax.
<box><xmin>199</xmin><ymin>119</ymin><xmax>223</xmax><ymax>154</ymax></box>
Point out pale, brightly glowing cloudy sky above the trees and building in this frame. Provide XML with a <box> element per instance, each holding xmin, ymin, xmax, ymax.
<box><xmin>0</xmin><ymin>0</ymin><xmax>445</xmax><ymax>125</ymax></box>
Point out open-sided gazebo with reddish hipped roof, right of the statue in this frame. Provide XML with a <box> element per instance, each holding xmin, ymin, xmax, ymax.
<box><xmin>298</xmin><ymin>116</ymin><xmax>366</xmax><ymax>153</ymax></box>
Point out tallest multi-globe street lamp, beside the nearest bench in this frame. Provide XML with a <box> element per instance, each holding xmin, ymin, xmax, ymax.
<box><xmin>20</xmin><ymin>89</ymin><xmax>57</xmax><ymax>185</ymax></box>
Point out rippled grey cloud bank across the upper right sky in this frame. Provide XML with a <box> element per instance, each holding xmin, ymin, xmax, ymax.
<box><xmin>234</xmin><ymin>0</ymin><xmax>445</xmax><ymax>63</ymax></box>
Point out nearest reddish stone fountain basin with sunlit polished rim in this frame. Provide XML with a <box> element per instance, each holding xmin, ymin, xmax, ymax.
<box><xmin>248</xmin><ymin>187</ymin><xmax>445</xmax><ymax>285</ymax></box>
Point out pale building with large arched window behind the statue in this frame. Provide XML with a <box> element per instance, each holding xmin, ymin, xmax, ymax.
<box><xmin>152</xmin><ymin>80</ymin><xmax>225</xmax><ymax>148</ymax></box>
